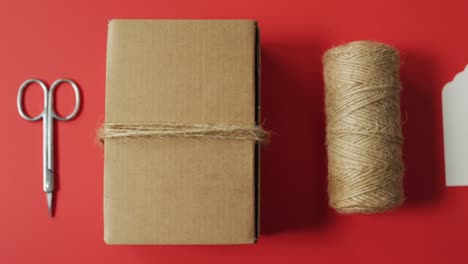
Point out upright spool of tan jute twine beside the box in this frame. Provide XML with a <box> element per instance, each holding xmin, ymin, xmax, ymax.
<box><xmin>323</xmin><ymin>41</ymin><xmax>404</xmax><ymax>213</ymax></box>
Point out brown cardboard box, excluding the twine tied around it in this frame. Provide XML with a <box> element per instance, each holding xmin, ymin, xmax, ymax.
<box><xmin>104</xmin><ymin>20</ymin><xmax>259</xmax><ymax>244</ymax></box>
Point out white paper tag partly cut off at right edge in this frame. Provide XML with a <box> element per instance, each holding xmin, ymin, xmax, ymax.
<box><xmin>442</xmin><ymin>65</ymin><xmax>468</xmax><ymax>186</ymax></box>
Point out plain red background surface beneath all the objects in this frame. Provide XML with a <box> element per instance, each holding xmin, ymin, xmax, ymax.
<box><xmin>0</xmin><ymin>0</ymin><xmax>468</xmax><ymax>264</ymax></box>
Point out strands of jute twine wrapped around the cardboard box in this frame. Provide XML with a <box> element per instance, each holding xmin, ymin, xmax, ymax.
<box><xmin>99</xmin><ymin>123</ymin><xmax>270</xmax><ymax>143</ymax></box>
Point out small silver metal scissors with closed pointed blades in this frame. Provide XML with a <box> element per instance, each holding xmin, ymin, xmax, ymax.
<box><xmin>16</xmin><ymin>79</ymin><xmax>81</xmax><ymax>217</ymax></box>
